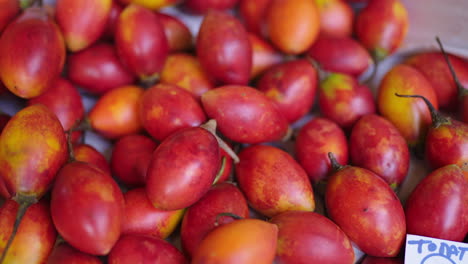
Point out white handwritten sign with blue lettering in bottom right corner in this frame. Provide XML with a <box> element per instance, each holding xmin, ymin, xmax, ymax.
<box><xmin>405</xmin><ymin>235</ymin><xmax>468</xmax><ymax>264</ymax></box>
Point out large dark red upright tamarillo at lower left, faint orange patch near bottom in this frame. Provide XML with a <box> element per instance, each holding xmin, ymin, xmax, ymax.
<box><xmin>50</xmin><ymin>161</ymin><xmax>124</xmax><ymax>255</ymax></box>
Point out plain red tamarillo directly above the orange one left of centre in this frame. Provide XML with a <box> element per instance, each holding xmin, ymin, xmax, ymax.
<box><xmin>67</xmin><ymin>42</ymin><xmax>136</xmax><ymax>95</ymax></box>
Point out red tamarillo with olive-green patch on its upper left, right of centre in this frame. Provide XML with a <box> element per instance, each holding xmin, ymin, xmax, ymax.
<box><xmin>318</xmin><ymin>73</ymin><xmax>376</xmax><ymax>129</ymax></box>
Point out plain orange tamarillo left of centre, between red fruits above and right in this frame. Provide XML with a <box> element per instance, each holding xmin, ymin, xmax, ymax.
<box><xmin>88</xmin><ymin>85</ymin><xmax>145</xmax><ymax>139</ymax></box>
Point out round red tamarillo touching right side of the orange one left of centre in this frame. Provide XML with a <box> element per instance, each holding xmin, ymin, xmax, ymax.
<box><xmin>139</xmin><ymin>83</ymin><xmax>206</xmax><ymax>141</ymax></box>
